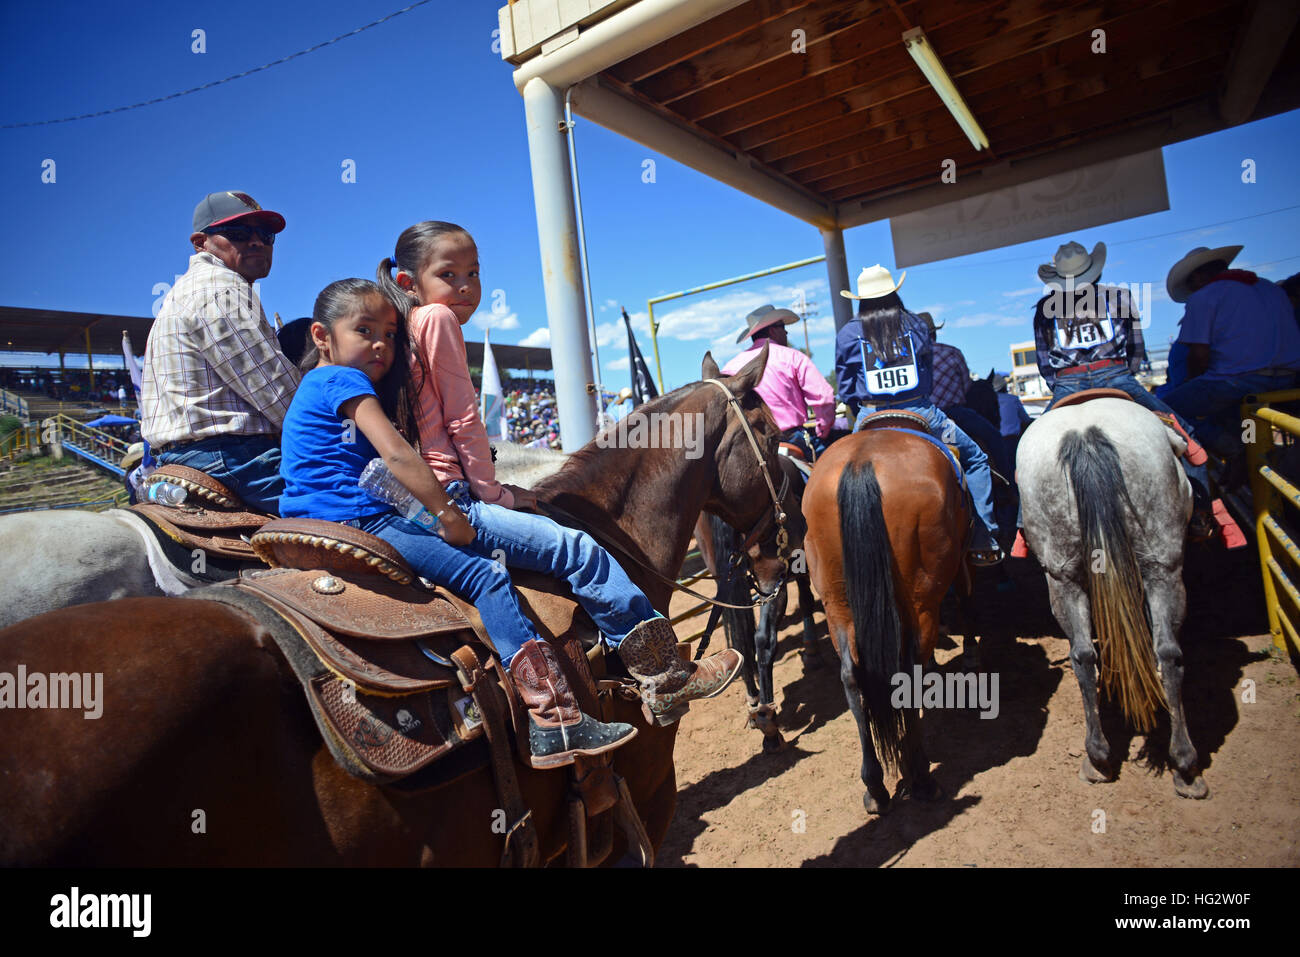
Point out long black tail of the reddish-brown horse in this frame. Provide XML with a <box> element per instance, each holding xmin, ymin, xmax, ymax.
<box><xmin>839</xmin><ymin>462</ymin><xmax>904</xmax><ymax>767</ymax></box>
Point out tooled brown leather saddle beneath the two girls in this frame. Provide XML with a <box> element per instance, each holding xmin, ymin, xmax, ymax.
<box><xmin>209</xmin><ymin>519</ymin><xmax>653</xmax><ymax>866</ymax></box>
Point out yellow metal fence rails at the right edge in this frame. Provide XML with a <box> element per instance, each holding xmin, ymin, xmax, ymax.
<box><xmin>1242</xmin><ymin>389</ymin><xmax>1300</xmax><ymax>658</ymax></box>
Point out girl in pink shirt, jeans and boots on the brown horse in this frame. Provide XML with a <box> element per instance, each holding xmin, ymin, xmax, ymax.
<box><xmin>378</xmin><ymin>221</ymin><xmax>744</xmax><ymax>724</ymax></box>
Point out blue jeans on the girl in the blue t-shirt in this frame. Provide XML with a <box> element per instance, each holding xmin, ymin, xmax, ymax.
<box><xmin>347</xmin><ymin>512</ymin><xmax>541</xmax><ymax>668</ymax></box>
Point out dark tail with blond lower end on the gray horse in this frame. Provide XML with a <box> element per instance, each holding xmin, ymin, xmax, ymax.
<box><xmin>1057</xmin><ymin>425</ymin><xmax>1166</xmax><ymax>731</ymax></box>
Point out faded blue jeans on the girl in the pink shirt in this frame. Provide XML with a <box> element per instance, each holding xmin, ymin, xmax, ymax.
<box><xmin>447</xmin><ymin>481</ymin><xmax>659</xmax><ymax>646</ymax></box>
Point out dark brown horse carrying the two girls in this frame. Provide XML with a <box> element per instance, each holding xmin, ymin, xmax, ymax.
<box><xmin>0</xmin><ymin>355</ymin><xmax>779</xmax><ymax>866</ymax></box>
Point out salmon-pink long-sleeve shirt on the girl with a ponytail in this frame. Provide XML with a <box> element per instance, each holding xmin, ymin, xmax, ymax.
<box><xmin>410</xmin><ymin>303</ymin><xmax>515</xmax><ymax>508</ymax></box>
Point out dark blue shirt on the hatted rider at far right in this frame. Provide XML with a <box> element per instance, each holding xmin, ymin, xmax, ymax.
<box><xmin>1178</xmin><ymin>280</ymin><xmax>1300</xmax><ymax>380</ymax></box>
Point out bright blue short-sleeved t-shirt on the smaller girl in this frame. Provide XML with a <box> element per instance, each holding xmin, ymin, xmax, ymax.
<box><xmin>280</xmin><ymin>365</ymin><xmax>391</xmax><ymax>521</ymax></box>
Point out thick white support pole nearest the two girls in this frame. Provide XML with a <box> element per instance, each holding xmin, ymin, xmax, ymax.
<box><xmin>524</xmin><ymin>77</ymin><xmax>595</xmax><ymax>452</ymax></box>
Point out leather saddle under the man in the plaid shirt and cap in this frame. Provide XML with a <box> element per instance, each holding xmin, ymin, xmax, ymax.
<box><xmin>130</xmin><ymin>465</ymin><xmax>276</xmax><ymax>563</ymax></box>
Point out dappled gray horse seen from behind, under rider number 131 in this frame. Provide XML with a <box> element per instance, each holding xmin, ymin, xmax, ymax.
<box><xmin>1015</xmin><ymin>398</ymin><xmax>1209</xmax><ymax>797</ymax></box>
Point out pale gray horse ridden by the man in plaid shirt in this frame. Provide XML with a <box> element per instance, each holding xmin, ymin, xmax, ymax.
<box><xmin>0</xmin><ymin>442</ymin><xmax>566</xmax><ymax>628</ymax></box>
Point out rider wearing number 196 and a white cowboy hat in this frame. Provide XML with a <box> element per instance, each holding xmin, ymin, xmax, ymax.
<box><xmin>835</xmin><ymin>265</ymin><xmax>1004</xmax><ymax>564</ymax></box>
